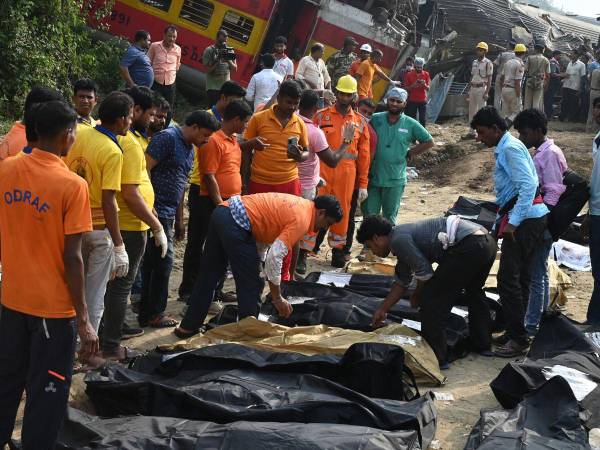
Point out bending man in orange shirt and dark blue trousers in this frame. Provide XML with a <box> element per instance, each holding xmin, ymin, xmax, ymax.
<box><xmin>174</xmin><ymin>192</ymin><xmax>343</xmax><ymax>339</ymax></box>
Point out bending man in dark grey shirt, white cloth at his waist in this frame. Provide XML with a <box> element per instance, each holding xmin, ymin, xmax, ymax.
<box><xmin>356</xmin><ymin>216</ymin><xmax>497</xmax><ymax>369</ymax></box>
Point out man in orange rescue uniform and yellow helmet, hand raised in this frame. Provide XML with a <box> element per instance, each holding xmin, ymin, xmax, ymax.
<box><xmin>300</xmin><ymin>75</ymin><xmax>370</xmax><ymax>267</ymax></box>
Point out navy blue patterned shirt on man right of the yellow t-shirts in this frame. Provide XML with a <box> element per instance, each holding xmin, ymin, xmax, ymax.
<box><xmin>146</xmin><ymin>127</ymin><xmax>194</xmax><ymax>219</ymax></box>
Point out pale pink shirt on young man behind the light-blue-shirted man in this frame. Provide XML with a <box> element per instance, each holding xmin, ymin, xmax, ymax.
<box><xmin>533</xmin><ymin>139</ymin><xmax>568</xmax><ymax>206</ymax></box>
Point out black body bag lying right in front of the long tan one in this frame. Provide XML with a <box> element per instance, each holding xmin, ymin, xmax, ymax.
<box><xmin>131</xmin><ymin>343</ymin><xmax>419</xmax><ymax>401</ymax></box>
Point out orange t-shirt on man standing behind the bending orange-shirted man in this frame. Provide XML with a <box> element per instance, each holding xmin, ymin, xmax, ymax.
<box><xmin>198</xmin><ymin>130</ymin><xmax>242</xmax><ymax>198</ymax></box>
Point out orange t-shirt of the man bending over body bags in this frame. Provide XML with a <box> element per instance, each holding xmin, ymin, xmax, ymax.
<box><xmin>242</xmin><ymin>192</ymin><xmax>315</xmax><ymax>248</ymax></box>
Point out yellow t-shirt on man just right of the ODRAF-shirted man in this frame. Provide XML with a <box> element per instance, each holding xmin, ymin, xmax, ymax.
<box><xmin>64</xmin><ymin>126</ymin><xmax>123</xmax><ymax>225</ymax></box>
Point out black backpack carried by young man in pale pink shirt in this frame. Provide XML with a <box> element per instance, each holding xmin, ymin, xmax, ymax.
<box><xmin>548</xmin><ymin>170</ymin><xmax>590</xmax><ymax>241</ymax></box>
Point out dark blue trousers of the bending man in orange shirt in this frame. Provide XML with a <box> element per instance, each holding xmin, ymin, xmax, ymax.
<box><xmin>181</xmin><ymin>206</ymin><xmax>264</xmax><ymax>330</ymax></box>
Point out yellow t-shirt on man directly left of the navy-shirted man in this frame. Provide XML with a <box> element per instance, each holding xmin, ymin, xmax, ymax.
<box><xmin>117</xmin><ymin>130</ymin><xmax>154</xmax><ymax>231</ymax></box>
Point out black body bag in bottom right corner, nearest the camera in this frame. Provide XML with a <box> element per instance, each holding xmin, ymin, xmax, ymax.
<box><xmin>465</xmin><ymin>377</ymin><xmax>590</xmax><ymax>450</ymax></box>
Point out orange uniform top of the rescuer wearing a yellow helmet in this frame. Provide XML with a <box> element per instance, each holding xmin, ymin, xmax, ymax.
<box><xmin>313</xmin><ymin>105</ymin><xmax>371</xmax><ymax>189</ymax></box>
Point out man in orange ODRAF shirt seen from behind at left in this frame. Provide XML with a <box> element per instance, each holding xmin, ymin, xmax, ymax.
<box><xmin>0</xmin><ymin>101</ymin><xmax>98</xmax><ymax>450</ymax></box>
